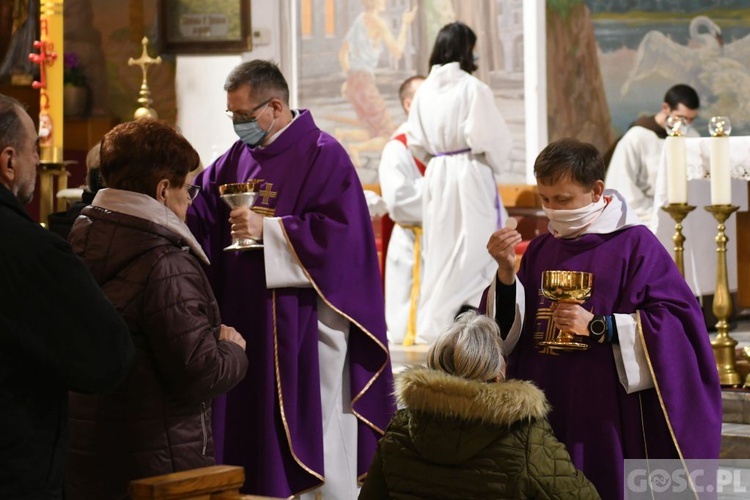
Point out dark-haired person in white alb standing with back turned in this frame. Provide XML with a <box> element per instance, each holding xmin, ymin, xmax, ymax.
<box><xmin>408</xmin><ymin>22</ymin><xmax>512</xmax><ymax>344</ymax></box>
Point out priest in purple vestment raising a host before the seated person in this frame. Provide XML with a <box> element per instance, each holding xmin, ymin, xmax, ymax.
<box><xmin>483</xmin><ymin>139</ymin><xmax>722</xmax><ymax>499</ymax></box>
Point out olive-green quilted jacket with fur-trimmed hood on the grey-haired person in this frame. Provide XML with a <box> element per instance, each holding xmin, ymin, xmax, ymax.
<box><xmin>359</xmin><ymin>367</ymin><xmax>599</xmax><ymax>500</ymax></box>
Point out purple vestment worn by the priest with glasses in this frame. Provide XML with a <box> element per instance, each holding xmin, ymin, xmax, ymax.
<box><xmin>188</xmin><ymin>110</ymin><xmax>395</xmax><ymax>497</ymax></box>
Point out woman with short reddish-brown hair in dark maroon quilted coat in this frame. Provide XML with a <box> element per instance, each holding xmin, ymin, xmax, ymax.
<box><xmin>66</xmin><ymin>120</ymin><xmax>247</xmax><ymax>499</ymax></box>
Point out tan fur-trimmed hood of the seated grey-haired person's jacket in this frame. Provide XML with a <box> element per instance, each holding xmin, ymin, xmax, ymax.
<box><xmin>396</xmin><ymin>366</ymin><xmax>549</xmax><ymax>463</ymax></box>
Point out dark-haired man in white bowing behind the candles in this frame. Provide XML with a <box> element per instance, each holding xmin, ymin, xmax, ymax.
<box><xmin>606</xmin><ymin>84</ymin><xmax>700</xmax><ymax>224</ymax></box>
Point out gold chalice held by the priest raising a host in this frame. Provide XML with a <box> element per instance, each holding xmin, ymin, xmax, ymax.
<box><xmin>539</xmin><ymin>271</ymin><xmax>594</xmax><ymax>351</ymax></box>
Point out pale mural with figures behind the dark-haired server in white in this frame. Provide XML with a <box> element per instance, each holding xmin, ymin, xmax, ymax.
<box><xmin>289</xmin><ymin>0</ymin><xmax>525</xmax><ymax>183</ymax></box>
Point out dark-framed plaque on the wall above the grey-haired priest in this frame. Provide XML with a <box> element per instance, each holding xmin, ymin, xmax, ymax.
<box><xmin>159</xmin><ymin>0</ymin><xmax>252</xmax><ymax>54</ymax></box>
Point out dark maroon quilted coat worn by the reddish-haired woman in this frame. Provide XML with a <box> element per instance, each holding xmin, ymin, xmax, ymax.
<box><xmin>66</xmin><ymin>207</ymin><xmax>247</xmax><ymax>500</ymax></box>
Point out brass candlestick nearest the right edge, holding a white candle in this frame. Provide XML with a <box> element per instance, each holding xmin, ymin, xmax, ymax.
<box><xmin>704</xmin><ymin>205</ymin><xmax>740</xmax><ymax>387</ymax></box>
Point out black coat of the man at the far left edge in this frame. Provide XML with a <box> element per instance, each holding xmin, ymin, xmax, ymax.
<box><xmin>0</xmin><ymin>186</ymin><xmax>134</xmax><ymax>499</ymax></box>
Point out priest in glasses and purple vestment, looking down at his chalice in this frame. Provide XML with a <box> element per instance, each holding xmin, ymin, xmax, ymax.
<box><xmin>188</xmin><ymin>60</ymin><xmax>395</xmax><ymax>498</ymax></box>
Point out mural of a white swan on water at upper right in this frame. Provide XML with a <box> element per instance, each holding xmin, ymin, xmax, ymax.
<box><xmin>585</xmin><ymin>0</ymin><xmax>750</xmax><ymax>137</ymax></box>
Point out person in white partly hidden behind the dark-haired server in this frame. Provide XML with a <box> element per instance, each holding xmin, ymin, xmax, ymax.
<box><xmin>378</xmin><ymin>75</ymin><xmax>425</xmax><ymax>345</ymax></box>
